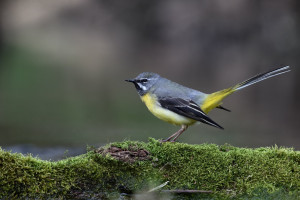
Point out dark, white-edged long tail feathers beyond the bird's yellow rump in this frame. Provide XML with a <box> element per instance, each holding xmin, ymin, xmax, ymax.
<box><xmin>232</xmin><ymin>66</ymin><xmax>291</xmax><ymax>91</ymax></box>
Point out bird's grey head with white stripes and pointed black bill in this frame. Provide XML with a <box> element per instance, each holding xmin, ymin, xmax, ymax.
<box><xmin>125</xmin><ymin>72</ymin><xmax>160</xmax><ymax>96</ymax></box>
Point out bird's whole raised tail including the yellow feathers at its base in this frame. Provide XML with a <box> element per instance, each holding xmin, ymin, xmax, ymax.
<box><xmin>201</xmin><ymin>66</ymin><xmax>290</xmax><ymax>113</ymax></box>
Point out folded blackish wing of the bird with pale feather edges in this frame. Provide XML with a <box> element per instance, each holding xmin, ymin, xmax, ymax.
<box><xmin>158</xmin><ymin>97</ymin><xmax>224</xmax><ymax>129</ymax></box>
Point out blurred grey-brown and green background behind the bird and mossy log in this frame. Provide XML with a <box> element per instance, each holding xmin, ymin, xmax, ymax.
<box><xmin>0</xmin><ymin>0</ymin><xmax>300</xmax><ymax>160</ymax></box>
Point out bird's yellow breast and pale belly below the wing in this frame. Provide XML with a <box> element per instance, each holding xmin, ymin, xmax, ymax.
<box><xmin>141</xmin><ymin>93</ymin><xmax>196</xmax><ymax>125</ymax></box>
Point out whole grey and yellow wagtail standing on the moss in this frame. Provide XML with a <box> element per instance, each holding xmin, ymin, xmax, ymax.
<box><xmin>126</xmin><ymin>66</ymin><xmax>290</xmax><ymax>142</ymax></box>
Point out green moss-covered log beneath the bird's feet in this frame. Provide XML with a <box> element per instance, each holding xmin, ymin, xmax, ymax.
<box><xmin>0</xmin><ymin>139</ymin><xmax>300</xmax><ymax>199</ymax></box>
